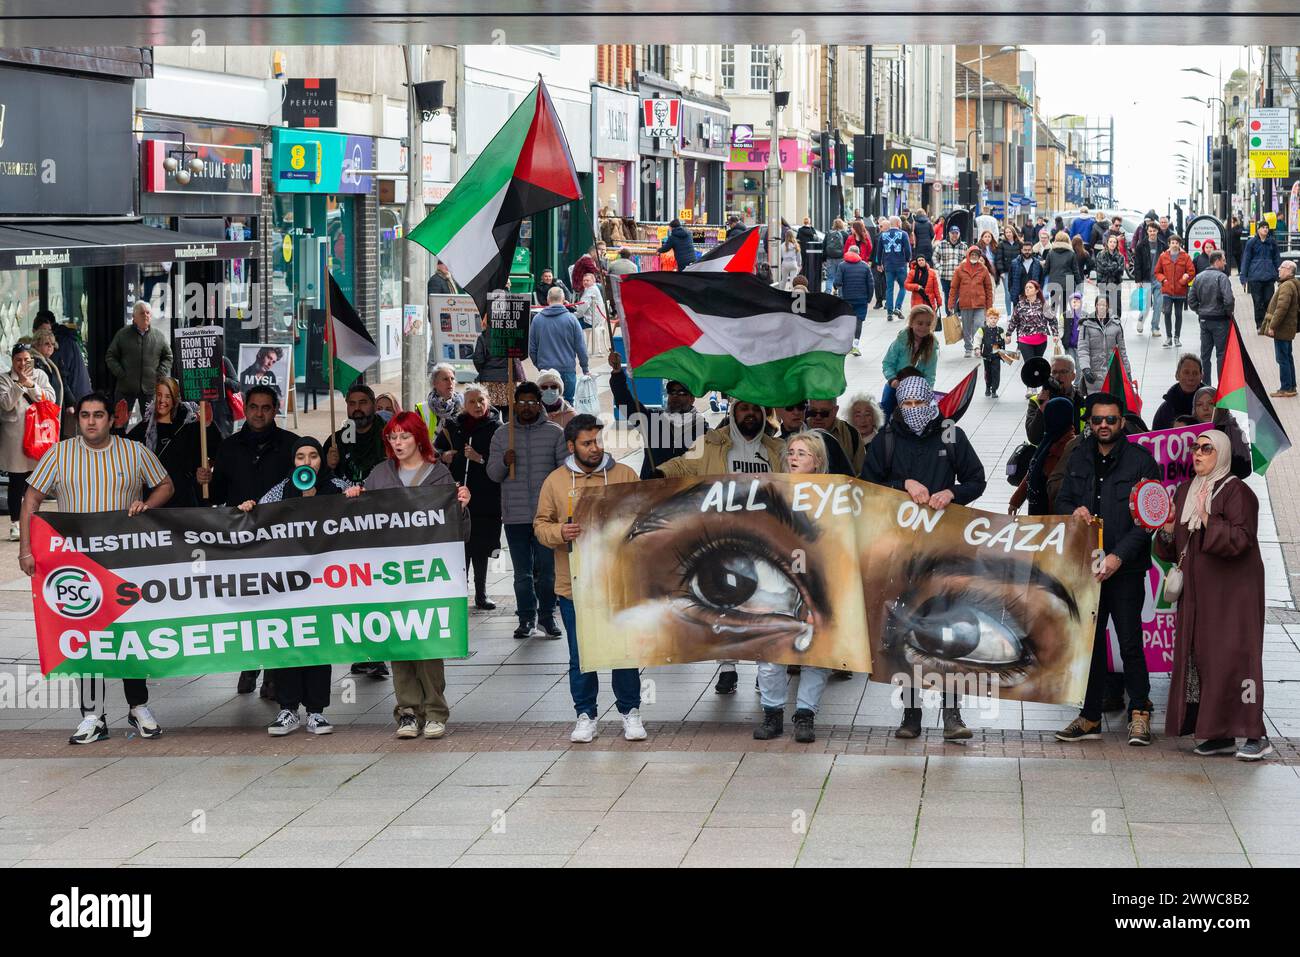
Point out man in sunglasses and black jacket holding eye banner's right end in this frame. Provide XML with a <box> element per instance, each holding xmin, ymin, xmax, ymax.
<box><xmin>1053</xmin><ymin>393</ymin><xmax>1161</xmax><ymax>746</ymax></box>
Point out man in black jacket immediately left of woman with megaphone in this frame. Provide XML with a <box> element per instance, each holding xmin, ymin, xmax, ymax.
<box><xmin>195</xmin><ymin>385</ymin><xmax>298</xmax><ymax>698</ymax></box>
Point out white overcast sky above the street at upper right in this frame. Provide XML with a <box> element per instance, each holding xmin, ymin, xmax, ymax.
<box><xmin>1027</xmin><ymin>46</ymin><xmax>1258</xmax><ymax>212</ymax></box>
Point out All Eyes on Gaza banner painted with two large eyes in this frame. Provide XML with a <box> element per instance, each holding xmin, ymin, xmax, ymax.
<box><xmin>571</xmin><ymin>475</ymin><xmax>1100</xmax><ymax>705</ymax></box>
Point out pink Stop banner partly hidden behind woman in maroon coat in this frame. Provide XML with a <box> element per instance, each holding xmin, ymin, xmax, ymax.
<box><xmin>1106</xmin><ymin>423</ymin><xmax>1216</xmax><ymax>674</ymax></box>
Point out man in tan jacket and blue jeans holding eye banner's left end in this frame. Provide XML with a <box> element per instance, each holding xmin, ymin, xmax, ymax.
<box><xmin>533</xmin><ymin>413</ymin><xmax>646</xmax><ymax>744</ymax></box>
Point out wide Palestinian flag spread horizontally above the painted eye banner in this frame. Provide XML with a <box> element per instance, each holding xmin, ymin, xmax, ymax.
<box><xmin>619</xmin><ymin>272</ymin><xmax>855</xmax><ymax>407</ymax></box>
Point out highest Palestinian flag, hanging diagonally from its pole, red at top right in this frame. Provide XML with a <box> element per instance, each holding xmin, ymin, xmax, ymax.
<box><xmin>407</xmin><ymin>81</ymin><xmax>582</xmax><ymax>312</ymax></box>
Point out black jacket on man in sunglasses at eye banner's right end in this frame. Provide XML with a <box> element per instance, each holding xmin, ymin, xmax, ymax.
<box><xmin>1055</xmin><ymin>436</ymin><xmax>1161</xmax><ymax>575</ymax></box>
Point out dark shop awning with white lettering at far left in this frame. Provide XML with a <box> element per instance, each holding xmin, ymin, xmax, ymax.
<box><xmin>0</xmin><ymin>222</ymin><xmax>259</xmax><ymax>269</ymax></box>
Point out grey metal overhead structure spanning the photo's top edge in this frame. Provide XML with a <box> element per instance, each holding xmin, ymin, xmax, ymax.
<box><xmin>0</xmin><ymin>0</ymin><xmax>1300</xmax><ymax>47</ymax></box>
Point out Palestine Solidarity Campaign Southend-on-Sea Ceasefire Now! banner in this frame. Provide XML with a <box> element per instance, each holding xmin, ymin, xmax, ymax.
<box><xmin>31</xmin><ymin>485</ymin><xmax>469</xmax><ymax>677</ymax></box>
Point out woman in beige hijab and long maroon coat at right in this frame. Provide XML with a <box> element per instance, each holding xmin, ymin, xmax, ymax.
<box><xmin>1156</xmin><ymin>429</ymin><xmax>1273</xmax><ymax>761</ymax></box>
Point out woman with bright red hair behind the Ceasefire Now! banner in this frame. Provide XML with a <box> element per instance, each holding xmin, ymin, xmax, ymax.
<box><xmin>345</xmin><ymin>412</ymin><xmax>469</xmax><ymax>739</ymax></box>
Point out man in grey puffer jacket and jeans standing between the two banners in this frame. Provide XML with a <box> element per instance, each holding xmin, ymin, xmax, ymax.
<box><xmin>488</xmin><ymin>382</ymin><xmax>568</xmax><ymax>640</ymax></box>
